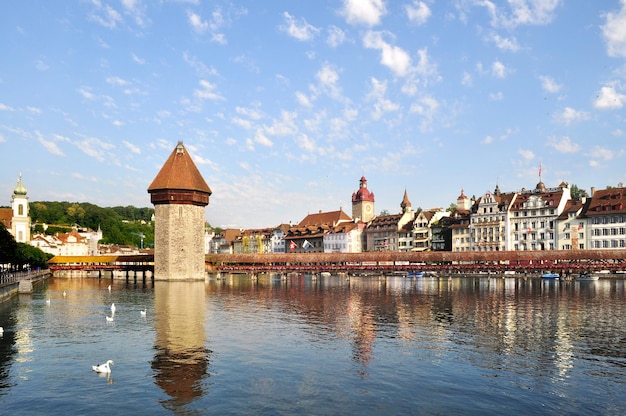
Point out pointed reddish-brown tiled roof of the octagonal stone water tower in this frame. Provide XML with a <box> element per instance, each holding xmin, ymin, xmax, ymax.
<box><xmin>148</xmin><ymin>142</ymin><xmax>212</xmax><ymax>195</ymax></box>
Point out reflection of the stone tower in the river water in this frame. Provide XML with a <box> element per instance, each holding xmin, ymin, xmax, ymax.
<box><xmin>152</xmin><ymin>282</ymin><xmax>210</xmax><ymax>411</ymax></box>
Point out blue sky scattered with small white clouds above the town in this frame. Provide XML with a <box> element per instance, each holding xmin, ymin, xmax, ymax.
<box><xmin>0</xmin><ymin>0</ymin><xmax>626</xmax><ymax>228</ymax></box>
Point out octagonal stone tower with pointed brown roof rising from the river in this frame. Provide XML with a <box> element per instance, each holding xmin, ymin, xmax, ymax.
<box><xmin>148</xmin><ymin>142</ymin><xmax>212</xmax><ymax>280</ymax></box>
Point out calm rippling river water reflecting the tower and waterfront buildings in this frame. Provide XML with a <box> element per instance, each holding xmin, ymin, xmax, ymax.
<box><xmin>0</xmin><ymin>275</ymin><xmax>626</xmax><ymax>415</ymax></box>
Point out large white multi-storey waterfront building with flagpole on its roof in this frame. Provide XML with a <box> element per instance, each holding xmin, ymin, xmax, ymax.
<box><xmin>506</xmin><ymin>181</ymin><xmax>571</xmax><ymax>251</ymax></box>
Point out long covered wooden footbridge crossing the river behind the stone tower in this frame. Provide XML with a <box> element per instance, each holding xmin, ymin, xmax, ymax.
<box><xmin>49</xmin><ymin>249</ymin><xmax>626</xmax><ymax>280</ymax></box>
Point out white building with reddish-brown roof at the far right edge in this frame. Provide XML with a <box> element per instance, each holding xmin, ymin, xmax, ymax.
<box><xmin>582</xmin><ymin>184</ymin><xmax>626</xmax><ymax>249</ymax></box>
